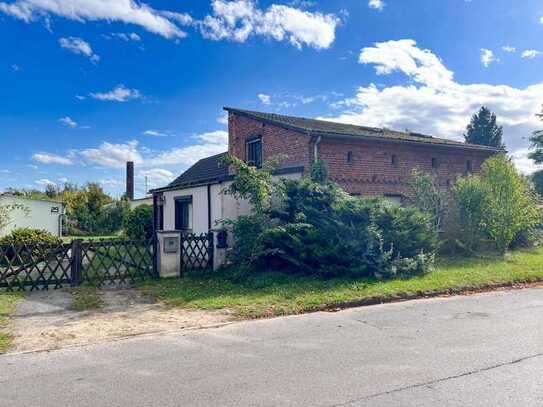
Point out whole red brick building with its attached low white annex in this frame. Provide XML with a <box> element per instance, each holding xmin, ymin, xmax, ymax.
<box><xmin>153</xmin><ymin>108</ymin><xmax>498</xmax><ymax>233</ymax></box>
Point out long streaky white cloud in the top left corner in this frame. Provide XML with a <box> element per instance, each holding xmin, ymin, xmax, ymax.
<box><xmin>0</xmin><ymin>0</ymin><xmax>186</xmax><ymax>38</ymax></box>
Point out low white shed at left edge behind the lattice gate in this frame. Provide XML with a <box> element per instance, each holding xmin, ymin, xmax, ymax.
<box><xmin>0</xmin><ymin>194</ymin><xmax>64</xmax><ymax>237</ymax></box>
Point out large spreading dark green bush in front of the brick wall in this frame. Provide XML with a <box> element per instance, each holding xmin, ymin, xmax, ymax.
<box><xmin>223</xmin><ymin>157</ymin><xmax>437</xmax><ymax>278</ymax></box>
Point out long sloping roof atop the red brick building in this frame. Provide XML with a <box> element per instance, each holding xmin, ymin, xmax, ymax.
<box><xmin>224</xmin><ymin>107</ymin><xmax>498</xmax><ymax>151</ymax></box>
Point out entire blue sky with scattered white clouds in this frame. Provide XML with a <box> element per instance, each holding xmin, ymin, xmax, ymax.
<box><xmin>0</xmin><ymin>0</ymin><xmax>543</xmax><ymax>195</ymax></box>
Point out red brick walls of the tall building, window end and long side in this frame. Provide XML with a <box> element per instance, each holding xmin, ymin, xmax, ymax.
<box><xmin>228</xmin><ymin>113</ymin><xmax>498</xmax><ymax>195</ymax></box>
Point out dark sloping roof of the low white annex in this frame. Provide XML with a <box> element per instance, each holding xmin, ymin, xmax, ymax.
<box><xmin>166</xmin><ymin>152</ymin><xmax>228</xmax><ymax>189</ymax></box>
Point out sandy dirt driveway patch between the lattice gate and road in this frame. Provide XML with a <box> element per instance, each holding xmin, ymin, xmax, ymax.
<box><xmin>8</xmin><ymin>289</ymin><xmax>231</xmax><ymax>352</ymax></box>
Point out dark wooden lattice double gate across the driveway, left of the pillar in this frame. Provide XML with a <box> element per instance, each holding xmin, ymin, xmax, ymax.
<box><xmin>0</xmin><ymin>240</ymin><xmax>157</xmax><ymax>290</ymax></box>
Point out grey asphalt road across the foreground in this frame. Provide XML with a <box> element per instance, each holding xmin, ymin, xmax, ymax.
<box><xmin>0</xmin><ymin>289</ymin><xmax>543</xmax><ymax>407</ymax></box>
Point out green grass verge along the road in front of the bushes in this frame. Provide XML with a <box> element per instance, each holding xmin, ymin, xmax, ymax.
<box><xmin>140</xmin><ymin>248</ymin><xmax>543</xmax><ymax>318</ymax></box>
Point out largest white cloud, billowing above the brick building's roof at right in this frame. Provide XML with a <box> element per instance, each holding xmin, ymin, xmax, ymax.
<box><xmin>327</xmin><ymin>40</ymin><xmax>543</xmax><ymax>175</ymax></box>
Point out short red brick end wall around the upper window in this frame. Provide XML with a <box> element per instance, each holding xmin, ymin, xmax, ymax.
<box><xmin>228</xmin><ymin>113</ymin><xmax>311</xmax><ymax>168</ymax></box>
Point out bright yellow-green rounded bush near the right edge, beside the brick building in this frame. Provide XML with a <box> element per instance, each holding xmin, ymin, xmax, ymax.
<box><xmin>454</xmin><ymin>154</ymin><xmax>541</xmax><ymax>254</ymax></box>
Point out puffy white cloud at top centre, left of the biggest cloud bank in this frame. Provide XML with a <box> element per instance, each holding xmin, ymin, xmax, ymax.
<box><xmin>198</xmin><ymin>0</ymin><xmax>340</xmax><ymax>49</ymax></box>
